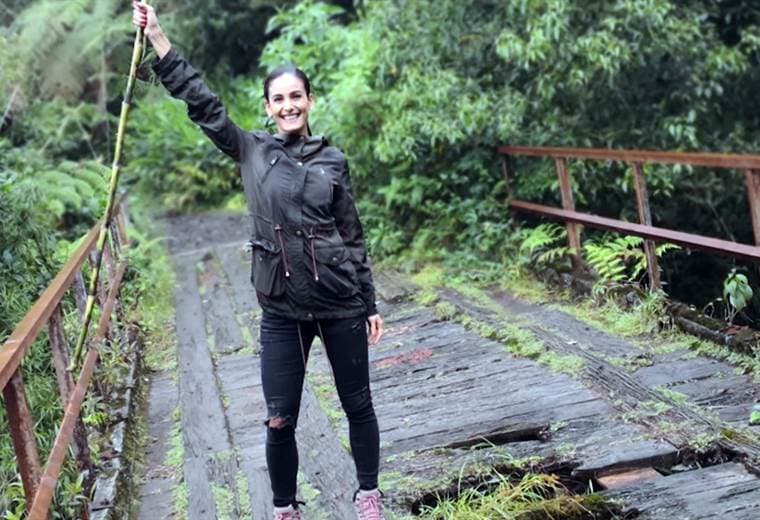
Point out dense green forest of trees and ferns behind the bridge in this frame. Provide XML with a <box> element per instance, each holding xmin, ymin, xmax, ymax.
<box><xmin>0</xmin><ymin>0</ymin><xmax>760</xmax><ymax>518</ymax></box>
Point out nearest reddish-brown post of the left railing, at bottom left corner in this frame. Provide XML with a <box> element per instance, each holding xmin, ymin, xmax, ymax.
<box><xmin>3</xmin><ymin>367</ymin><xmax>42</xmax><ymax>504</ymax></box>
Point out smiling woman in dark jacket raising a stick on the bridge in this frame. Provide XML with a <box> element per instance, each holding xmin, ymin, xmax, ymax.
<box><xmin>133</xmin><ymin>2</ymin><xmax>383</xmax><ymax>520</ymax></box>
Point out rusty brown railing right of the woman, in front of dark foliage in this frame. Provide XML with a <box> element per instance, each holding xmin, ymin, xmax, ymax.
<box><xmin>498</xmin><ymin>146</ymin><xmax>760</xmax><ymax>290</ymax></box>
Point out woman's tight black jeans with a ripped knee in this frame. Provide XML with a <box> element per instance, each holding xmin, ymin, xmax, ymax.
<box><xmin>260</xmin><ymin>312</ymin><xmax>380</xmax><ymax>507</ymax></box>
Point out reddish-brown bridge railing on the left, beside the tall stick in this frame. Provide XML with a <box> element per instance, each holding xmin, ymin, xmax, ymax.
<box><xmin>0</xmin><ymin>204</ymin><xmax>129</xmax><ymax>520</ymax></box>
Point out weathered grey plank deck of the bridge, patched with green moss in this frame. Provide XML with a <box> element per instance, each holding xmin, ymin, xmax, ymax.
<box><xmin>139</xmin><ymin>210</ymin><xmax>760</xmax><ymax>520</ymax></box>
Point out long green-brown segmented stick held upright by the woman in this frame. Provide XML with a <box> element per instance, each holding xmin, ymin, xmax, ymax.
<box><xmin>68</xmin><ymin>28</ymin><xmax>145</xmax><ymax>371</ymax></box>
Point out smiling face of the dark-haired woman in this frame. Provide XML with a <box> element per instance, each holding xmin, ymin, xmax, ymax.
<box><xmin>264</xmin><ymin>73</ymin><xmax>314</xmax><ymax>135</ymax></box>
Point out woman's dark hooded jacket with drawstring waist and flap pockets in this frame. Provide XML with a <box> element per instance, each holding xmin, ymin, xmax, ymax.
<box><xmin>153</xmin><ymin>49</ymin><xmax>377</xmax><ymax>320</ymax></box>
